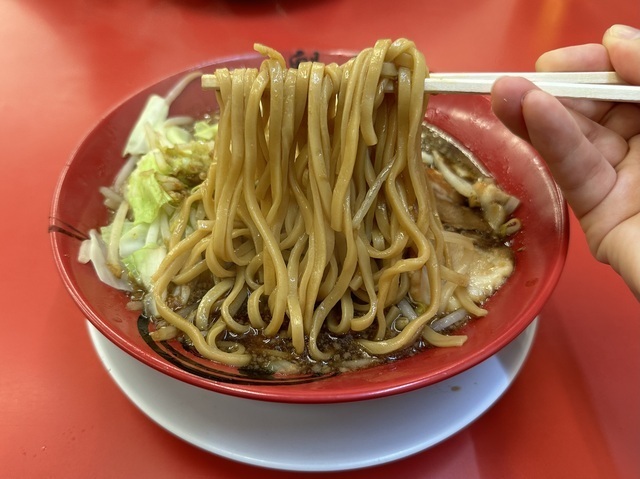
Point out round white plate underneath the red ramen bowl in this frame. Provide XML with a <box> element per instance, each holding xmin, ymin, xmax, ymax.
<box><xmin>88</xmin><ymin>319</ymin><xmax>538</xmax><ymax>471</ymax></box>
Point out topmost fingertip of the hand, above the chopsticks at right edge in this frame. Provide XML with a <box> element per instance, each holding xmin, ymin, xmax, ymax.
<box><xmin>602</xmin><ymin>25</ymin><xmax>640</xmax><ymax>85</ymax></box>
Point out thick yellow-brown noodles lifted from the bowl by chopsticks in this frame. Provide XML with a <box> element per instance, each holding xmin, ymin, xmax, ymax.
<box><xmin>144</xmin><ymin>39</ymin><xmax>504</xmax><ymax>366</ymax></box>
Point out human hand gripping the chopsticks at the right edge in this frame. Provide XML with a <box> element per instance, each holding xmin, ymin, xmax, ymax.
<box><xmin>492</xmin><ymin>25</ymin><xmax>640</xmax><ymax>299</ymax></box>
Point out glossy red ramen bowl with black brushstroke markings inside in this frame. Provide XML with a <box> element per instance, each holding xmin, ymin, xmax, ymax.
<box><xmin>50</xmin><ymin>50</ymin><xmax>569</xmax><ymax>403</ymax></box>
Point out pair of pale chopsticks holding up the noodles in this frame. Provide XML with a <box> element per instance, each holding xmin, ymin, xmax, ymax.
<box><xmin>202</xmin><ymin>71</ymin><xmax>640</xmax><ymax>102</ymax></box>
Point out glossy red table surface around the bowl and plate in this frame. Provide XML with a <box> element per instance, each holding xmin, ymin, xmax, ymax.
<box><xmin>0</xmin><ymin>0</ymin><xmax>640</xmax><ymax>479</ymax></box>
